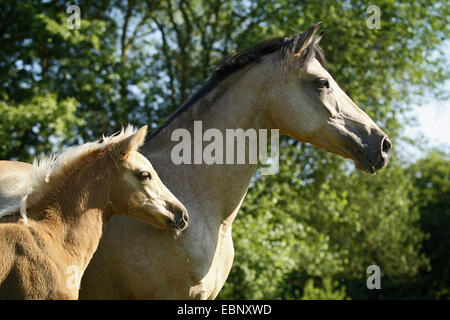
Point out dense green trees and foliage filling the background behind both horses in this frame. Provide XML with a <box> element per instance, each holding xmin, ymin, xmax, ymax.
<box><xmin>0</xmin><ymin>0</ymin><xmax>450</xmax><ymax>299</ymax></box>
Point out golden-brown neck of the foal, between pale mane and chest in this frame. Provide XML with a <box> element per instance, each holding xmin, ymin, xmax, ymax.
<box><xmin>27</xmin><ymin>152</ymin><xmax>113</xmax><ymax>270</ymax></box>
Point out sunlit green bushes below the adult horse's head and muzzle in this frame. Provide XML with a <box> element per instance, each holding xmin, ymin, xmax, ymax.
<box><xmin>220</xmin><ymin>148</ymin><xmax>428</xmax><ymax>299</ymax></box>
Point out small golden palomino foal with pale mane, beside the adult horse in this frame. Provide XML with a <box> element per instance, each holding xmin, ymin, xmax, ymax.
<box><xmin>0</xmin><ymin>127</ymin><xmax>187</xmax><ymax>299</ymax></box>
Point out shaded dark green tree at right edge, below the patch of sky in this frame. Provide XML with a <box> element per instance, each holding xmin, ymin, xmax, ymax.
<box><xmin>408</xmin><ymin>151</ymin><xmax>450</xmax><ymax>299</ymax></box>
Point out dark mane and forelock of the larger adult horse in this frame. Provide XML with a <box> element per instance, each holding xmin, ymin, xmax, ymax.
<box><xmin>147</xmin><ymin>33</ymin><xmax>325</xmax><ymax>140</ymax></box>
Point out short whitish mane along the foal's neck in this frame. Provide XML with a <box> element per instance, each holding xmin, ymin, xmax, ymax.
<box><xmin>0</xmin><ymin>125</ymin><xmax>137</xmax><ymax>222</ymax></box>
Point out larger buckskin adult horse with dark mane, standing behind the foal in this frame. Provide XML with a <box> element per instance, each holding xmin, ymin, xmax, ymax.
<box><xmin>0</xmin><ymin>23</ymin><xmax>391</xmax><ymax>299</ymax></box>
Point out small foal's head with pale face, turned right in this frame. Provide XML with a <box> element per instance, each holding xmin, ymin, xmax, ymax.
<box><xmin>105</xmin><ymin>126</ymin><xmax>189</xmax><ymax>233</ymax></box>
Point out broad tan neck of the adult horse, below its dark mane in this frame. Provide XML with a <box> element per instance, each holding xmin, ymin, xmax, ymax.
<box><xmin>141</xmin><ymin>66</ymin><xmax>267</xmax><ymax>225</ymax></box>
